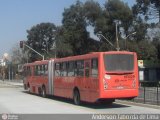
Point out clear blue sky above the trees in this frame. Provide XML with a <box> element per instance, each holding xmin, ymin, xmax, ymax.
<box><xmin>0</xmin><ymin>0</ymin><xmax>135</xmax><ymax>58</ymax></box>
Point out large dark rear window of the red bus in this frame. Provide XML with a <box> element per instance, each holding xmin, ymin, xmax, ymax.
<box><xmin>104</xmin><ymin>54</ymin><xmax>134</xmax><ymax>72</ymax></box>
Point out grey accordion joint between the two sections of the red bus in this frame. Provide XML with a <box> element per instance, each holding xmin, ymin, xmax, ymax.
<box><xmin>48</xmin><ymin>60</ymin><xmax>54</xmax><ymax>95</ymax></box>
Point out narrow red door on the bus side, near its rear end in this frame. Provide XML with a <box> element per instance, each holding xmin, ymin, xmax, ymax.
<box><xmin>84</xmin><ymin>60</ymin><xmax>91</xmax><ymax>100</ymax></box>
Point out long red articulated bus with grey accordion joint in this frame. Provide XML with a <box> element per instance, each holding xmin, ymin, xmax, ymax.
<box><xmin>24</xmin><ymin>51</ymin><xmax>139</xmax><ymax>105</ymax></box>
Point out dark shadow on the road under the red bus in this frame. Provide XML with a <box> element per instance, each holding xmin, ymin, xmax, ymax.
<box><xmin>23</xmin><ymin>91</ymin><xmax>130</xmax><ymax>109</ymax></box>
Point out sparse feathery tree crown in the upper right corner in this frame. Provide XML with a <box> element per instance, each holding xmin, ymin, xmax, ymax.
<box><xmin>133</xmin><ymin>0</ymin><xmax>160</xmax><ymax>22</ymax></box>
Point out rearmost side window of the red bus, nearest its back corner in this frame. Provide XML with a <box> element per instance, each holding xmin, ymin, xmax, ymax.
<box><xmin>91</xmin><ymin>58</ymin><xmax>98</xmax><ymax>77</ymax></box>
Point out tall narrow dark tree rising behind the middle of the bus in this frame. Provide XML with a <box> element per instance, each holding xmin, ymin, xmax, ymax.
<box><xmin>62</xmin><ymin>1</ymin><xmax>89</xmax><ymax>55</ymax></box>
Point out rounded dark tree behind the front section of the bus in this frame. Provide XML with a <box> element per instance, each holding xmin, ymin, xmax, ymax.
<box><xmin>27</xmin><ymin>23</ymin><xmax>56</xmax><ymax>61</ymax></box>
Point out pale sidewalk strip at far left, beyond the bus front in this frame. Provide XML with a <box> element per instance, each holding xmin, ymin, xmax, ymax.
<box><xmin>0</xmin><ymin>80</ymin><xmax>23</xmax><ymax>87</ymax></box>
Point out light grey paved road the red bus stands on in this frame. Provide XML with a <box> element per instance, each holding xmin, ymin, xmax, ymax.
<box><xmin>0</xmin><ymin>85</ymin><xmax>160</xmax><ymax>114</ymax></box>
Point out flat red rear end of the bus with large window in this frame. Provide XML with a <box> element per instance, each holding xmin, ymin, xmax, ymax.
<box><xmin>100</xmin><ymin>51</ymin><xmax>139</xmax><ymax>99</ymax></box>
